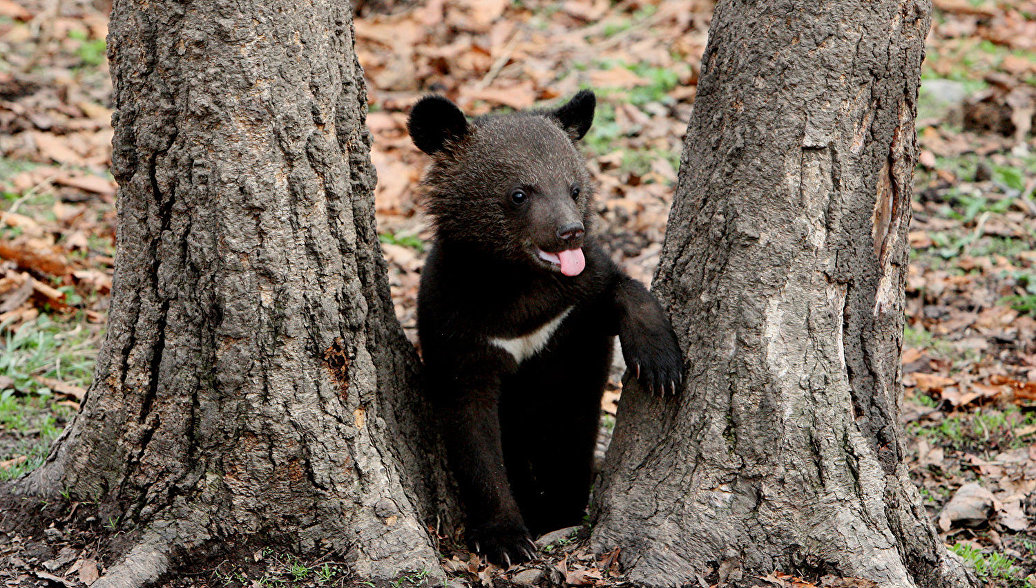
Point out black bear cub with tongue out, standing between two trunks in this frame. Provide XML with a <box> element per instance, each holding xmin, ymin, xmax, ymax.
<box><xmin>408</xmin><ymin>90</ymin><xmax>683</xmax><ymax>566</ymax></box>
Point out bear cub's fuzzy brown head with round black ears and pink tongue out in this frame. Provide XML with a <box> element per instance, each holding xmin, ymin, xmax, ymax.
<box><xmin>407</xmin><ymin>90</ymin><xmax>596</xmax><ymax>275</ymax></box>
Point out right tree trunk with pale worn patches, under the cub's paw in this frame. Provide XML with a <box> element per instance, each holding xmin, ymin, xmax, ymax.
<box><xmin>593</xmin><ymin>0</ymin><xmax>974</xmax><ymax>588</ymax></box>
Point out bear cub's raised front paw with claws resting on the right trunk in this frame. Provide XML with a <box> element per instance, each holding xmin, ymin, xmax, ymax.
<box><xmin>618</xmin><ymin>317</ymin><xmax>684</xmax><ymax>395</ymax></box>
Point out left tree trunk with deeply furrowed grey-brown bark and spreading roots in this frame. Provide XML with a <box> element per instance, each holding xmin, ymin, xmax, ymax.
<box><xmin>19</xmin><ymin>0</ymin><xmax>441</xmax><ymax>588</ymax></box>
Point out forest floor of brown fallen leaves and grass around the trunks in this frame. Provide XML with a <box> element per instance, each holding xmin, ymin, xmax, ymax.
<box><xmin>0</xmin><ymin>0</ymin><xmax>1036</xmax><ymax>588</ymax></box>
